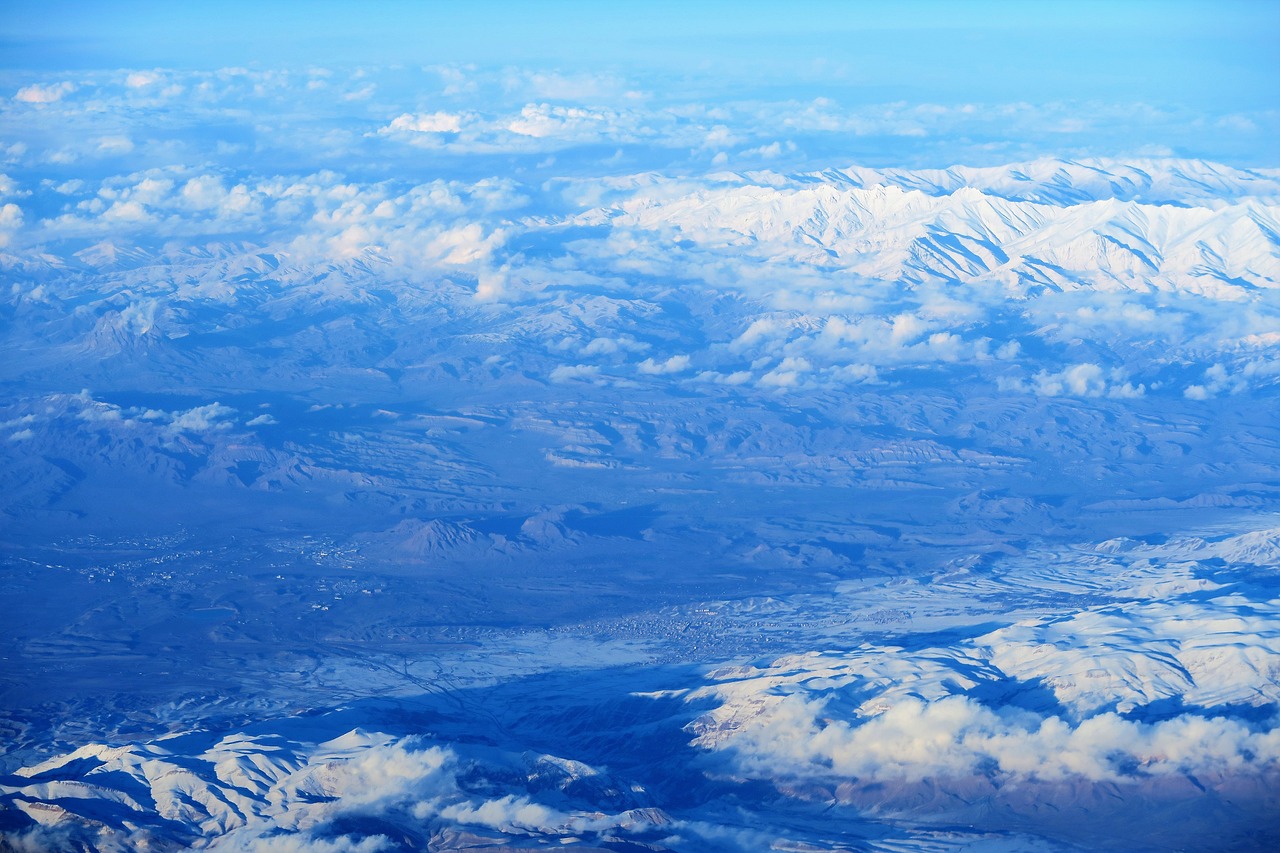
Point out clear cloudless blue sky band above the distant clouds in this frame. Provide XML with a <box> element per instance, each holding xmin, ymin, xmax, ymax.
<box><xmin>0</xmin><ymin>0</ymin><xmax>1280</xmax><ymax>109</ymax></box>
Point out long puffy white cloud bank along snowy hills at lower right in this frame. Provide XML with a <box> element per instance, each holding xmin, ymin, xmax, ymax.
<box><xmin>728</xmin><ymin>695</ymin><xmax>1280</xmax><ymax>784</ymax></box>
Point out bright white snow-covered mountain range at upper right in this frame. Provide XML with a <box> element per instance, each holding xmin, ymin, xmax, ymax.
<box><xmin>593</xmin><ymin>161</ymin><xmax>1280</xmax><ymax>300</ymax></box>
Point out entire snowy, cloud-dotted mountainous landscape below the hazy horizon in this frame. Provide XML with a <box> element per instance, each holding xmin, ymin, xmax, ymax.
<box><xmin>0</xmin><ymin>154</ymin><xmax>1280</xmax><ymax>852</ymax></box>
